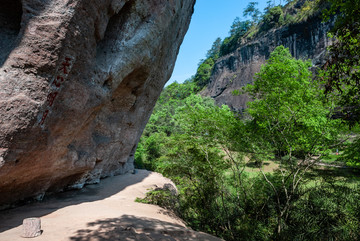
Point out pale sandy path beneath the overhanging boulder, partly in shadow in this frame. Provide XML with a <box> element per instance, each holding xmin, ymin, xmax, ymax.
<box><xmin>0</xmin><ymin>170</ymin><xmax>220</xmax><ymax>241</ymax></box>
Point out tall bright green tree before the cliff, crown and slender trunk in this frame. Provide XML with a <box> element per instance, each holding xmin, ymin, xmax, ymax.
<box><xmin>245</xmin><ymin>46</ymin><xmax>339</xmax><ymax>238</ymax></box>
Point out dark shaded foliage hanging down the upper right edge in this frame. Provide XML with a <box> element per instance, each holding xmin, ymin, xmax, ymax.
<box><xmin>320</xmin><ymin>0</ymin><xmax>360</xmax><ymax>126</ymax></box>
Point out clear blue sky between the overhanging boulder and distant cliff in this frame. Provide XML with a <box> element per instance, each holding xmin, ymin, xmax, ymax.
<box><xmin>167</xmin><ymin>0</ymin><xmax>270</xmax><ymax>84</ymax></box>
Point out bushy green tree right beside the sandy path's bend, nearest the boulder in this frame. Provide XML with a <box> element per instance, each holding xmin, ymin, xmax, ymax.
<box><xmin>158</xmin><ymin>95</ymin><xmax>237</xmax><ymax>236</ymax></box>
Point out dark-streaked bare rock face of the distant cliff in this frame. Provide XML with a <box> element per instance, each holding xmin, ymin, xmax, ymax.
<box><xmin>202</xmin><ymin>17</ymin><xmax>334</xmax><ymax>111</ymax></box>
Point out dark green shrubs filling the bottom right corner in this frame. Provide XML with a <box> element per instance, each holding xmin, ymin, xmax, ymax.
<box><xmin>286</xmin><ymin>183</ymin><xmax>360</xmax><ymax>240</ymax></box>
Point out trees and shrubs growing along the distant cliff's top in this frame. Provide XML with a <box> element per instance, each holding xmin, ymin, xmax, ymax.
<box><xmin>188</xmin><ymin>0</ymin><xmax>329</xmax><ymax>89</ymax></box>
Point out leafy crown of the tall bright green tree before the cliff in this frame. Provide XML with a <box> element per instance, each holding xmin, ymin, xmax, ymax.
<box><xmin>245</xmin><ymin>46</ymin><xmax>339</xmax><ymax>158</ymax></box>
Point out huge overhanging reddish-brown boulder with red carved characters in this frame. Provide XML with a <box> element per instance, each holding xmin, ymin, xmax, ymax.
<box><xmin>0</xmin><ymin>0</ymin><xmax>195</xmax><ymax>207</ymax></box>
